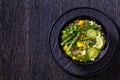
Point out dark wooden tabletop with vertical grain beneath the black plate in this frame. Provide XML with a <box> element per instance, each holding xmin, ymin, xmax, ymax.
<box><xmin>0</xmin><ymin>0</ymin><xmax>120</xmax><ymax>80</ymax></box>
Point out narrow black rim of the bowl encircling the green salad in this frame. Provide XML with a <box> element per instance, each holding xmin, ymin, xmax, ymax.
<box><xmin>58</xmin><ymin>15</ymin><xmax>109</xmax><ymax>65</ymax></box>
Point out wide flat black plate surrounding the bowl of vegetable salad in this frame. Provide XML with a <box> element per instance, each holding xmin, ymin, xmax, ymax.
<box><xmin>49</xmin><ymin>7</ymin><xmax>119</xmax><ymax>76</ymax></box>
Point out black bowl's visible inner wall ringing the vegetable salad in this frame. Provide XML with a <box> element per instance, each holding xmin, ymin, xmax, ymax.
<box><xmin>58</xmin><ymin>15</ymin><xmax>109</xmax><ymax>65</ymax></box>
